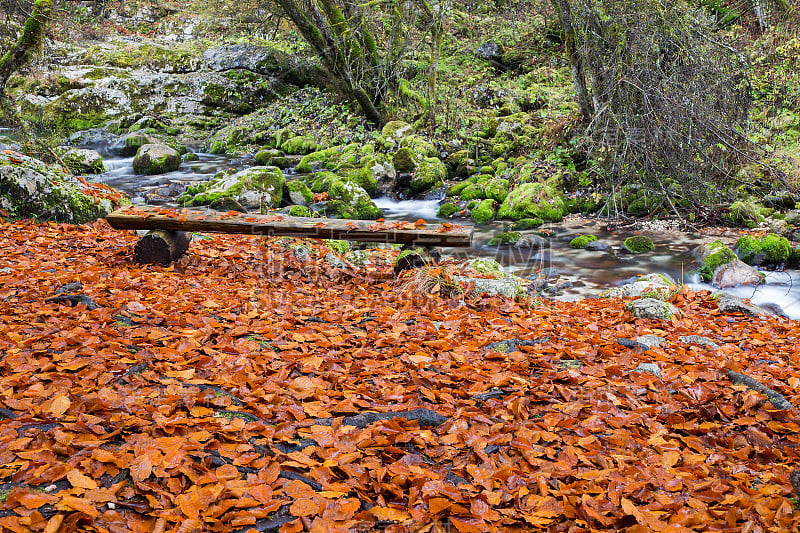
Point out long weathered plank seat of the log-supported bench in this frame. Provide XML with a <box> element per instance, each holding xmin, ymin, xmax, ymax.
<box><xmin>106</xmin><ymin>206</ymin><xmax>472</xmax><ymax>248</ymax></box>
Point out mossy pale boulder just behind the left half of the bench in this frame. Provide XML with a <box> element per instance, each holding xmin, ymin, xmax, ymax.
<box><xmin>178</xmin><ymin>167</ymin><xmax>285</xmax><ymax>212</ymax></box>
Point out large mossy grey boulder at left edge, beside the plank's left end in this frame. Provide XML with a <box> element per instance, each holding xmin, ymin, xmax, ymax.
<box><xmin>0</xmin><ymin>153</ymin><xmax>115</xmax><ymax>224</ymax></box>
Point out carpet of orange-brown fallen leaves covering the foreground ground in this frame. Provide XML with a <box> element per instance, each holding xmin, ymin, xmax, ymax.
<box><xmin>0</xmin><ymin>221</ymin><xmax>800</xmax><ymax>532</ymax></box>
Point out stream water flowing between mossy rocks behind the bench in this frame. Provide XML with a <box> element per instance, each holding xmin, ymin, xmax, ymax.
<box><xmin>79</xmin><ymin>143</ymin><xmax>800</xmax><ymax>319</ymax></box>
